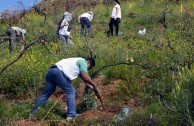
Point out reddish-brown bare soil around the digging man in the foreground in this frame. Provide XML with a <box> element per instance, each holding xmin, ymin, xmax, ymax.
<box><xmin>14</xmin><ymin>77</ymin><xmax>142</xmax><ymax>126</ymax></box>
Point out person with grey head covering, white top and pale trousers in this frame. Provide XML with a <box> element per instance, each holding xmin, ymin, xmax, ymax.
<box><xmin>57</xmin><ymin>12</ymin><xmax>74</xmax><ymax>46</ymax></box>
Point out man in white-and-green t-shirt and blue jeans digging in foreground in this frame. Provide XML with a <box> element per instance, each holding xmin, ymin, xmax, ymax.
<box><xmin>30</xmin><ymin>57</ymin><xmax>99</xmax><ymax>119</ymax></box>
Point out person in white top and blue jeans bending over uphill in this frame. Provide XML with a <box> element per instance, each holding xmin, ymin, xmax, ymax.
<box><xmin>78</xmin><ymin>11</ymin><xmax>93</xmax><ymax>35</ymax></box>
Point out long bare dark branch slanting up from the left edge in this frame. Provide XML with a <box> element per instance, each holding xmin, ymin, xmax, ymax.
<box><xmin>0</xmin><ymin>33</ymin><xmax>47</xmax><ymax>75</ymax></box>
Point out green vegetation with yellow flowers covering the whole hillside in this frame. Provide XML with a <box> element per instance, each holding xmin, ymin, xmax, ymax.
<box><xmin>0</xmin><ymin>0</ymin><xmax>194</xmax><ymax>126</ymax></box>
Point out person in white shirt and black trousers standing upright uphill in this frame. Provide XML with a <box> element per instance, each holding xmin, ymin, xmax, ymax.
<box><xmin>109</xmin><ymin>0</ymin><xmax>121</xmax><ymax>36</ymax></box>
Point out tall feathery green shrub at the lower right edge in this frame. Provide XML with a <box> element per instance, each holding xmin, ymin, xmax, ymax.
<box><xmin>170</xmin><ymin>68</ymin><xmax>194</xmax><ymax>125</ymax></box>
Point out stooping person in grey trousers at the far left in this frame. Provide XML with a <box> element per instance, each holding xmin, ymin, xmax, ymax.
<box><xmin>6</xmin><ymin>27</ymin><xmax>26</xmax><ymax>53</ymax></box>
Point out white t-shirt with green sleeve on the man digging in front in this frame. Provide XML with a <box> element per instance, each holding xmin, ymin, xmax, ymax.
<box><xmin>55</xmin><ymin>57</ymin><xmax>87</xmax><ymax>80</ymax></box>
